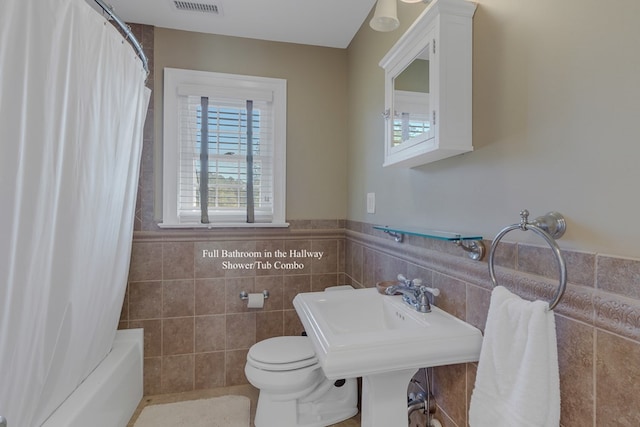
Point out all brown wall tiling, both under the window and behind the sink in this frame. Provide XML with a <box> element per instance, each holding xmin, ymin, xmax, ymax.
<box><xmin>121</xmin><ymin>221</ymin><xmax>640</xmax><ymax>427</ymax></box>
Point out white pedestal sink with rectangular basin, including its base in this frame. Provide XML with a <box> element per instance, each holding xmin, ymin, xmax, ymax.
<box><xmin>293</xmin><ymin>288</ymin><xmax>482</xmax><ymax>427</ymax></box>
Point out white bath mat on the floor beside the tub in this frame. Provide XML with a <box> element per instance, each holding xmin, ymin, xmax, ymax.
<box><xmin>134</xmin><ymin>396</ymin><xmax>250</xmax><ymax>427</ymax></box>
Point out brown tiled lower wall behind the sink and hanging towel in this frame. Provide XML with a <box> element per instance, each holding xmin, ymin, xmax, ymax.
<box><xmin>345</xmin><ymin>221</ymin><xmax>640</xmax><ymax>427</ymax></box>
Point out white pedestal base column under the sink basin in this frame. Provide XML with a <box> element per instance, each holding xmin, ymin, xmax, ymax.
<box><xmin>361</xmin><ymin>369</ymin><xmax>418</xmax><ymax>427</ymax></box>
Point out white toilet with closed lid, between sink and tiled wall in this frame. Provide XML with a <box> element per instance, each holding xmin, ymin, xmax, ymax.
<box><xmin>245</xmin><ymin>336</ymin><xmax>358</xmax><ymax>427</ymax></box>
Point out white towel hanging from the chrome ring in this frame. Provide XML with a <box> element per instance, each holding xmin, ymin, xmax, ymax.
<box><xmin>469</xmin><ymin>286</ymin><xmax>560</xmax><ymax>427</ymax></box>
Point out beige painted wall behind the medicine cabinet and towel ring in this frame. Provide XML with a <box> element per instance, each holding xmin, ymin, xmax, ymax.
<box><xmin>347</xmin><ymin>0</ymin><xmax>640</xmax><ymax>257</ymax></box>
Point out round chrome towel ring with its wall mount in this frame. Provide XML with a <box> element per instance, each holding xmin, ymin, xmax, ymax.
<box><xmin>488</xmin><ymin>209</ymin><xmax>567</xmax><ymax>310</ymax></box>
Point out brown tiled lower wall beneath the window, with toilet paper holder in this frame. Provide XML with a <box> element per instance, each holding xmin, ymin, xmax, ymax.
<box><xmin>120</xmin><ymin>226</ymin><xmax>344</xmax><ymax>395</ymax></box>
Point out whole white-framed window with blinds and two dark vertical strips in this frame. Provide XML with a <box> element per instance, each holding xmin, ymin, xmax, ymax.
<box><xmin>160</xmin><ymin>68</ymin><xmax>287</xmax><ymax>227</ymax></box>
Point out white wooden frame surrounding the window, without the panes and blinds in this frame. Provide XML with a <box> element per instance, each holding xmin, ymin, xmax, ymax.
<box><xmin>158</xmin><ymin>68</ymin><xmax>289</xmax><ymax>228</ymax></box>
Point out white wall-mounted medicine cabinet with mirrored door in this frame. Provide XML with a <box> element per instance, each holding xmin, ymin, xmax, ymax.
<box><xmin>380</xmin><ymin>0</ymin><xmax>476</xmax><ymax>168</ymax></box>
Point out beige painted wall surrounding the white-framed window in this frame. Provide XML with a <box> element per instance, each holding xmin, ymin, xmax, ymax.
<box><xmin>154</xmin><ymin>28</ymin><xmax>347</xmax><ymax>219</ymax></box>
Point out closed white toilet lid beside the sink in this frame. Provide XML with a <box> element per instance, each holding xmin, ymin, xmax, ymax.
<box><xmin>247</xmin><ymin>337</ymin><xmax>318</xmax><ymax>371</ymax></box>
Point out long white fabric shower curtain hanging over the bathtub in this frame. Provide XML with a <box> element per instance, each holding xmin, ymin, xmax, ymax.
<box><xmin>0</xmin><ymin>0</ymin><xmax>148</xmax><ymax>427</ymax></box>
